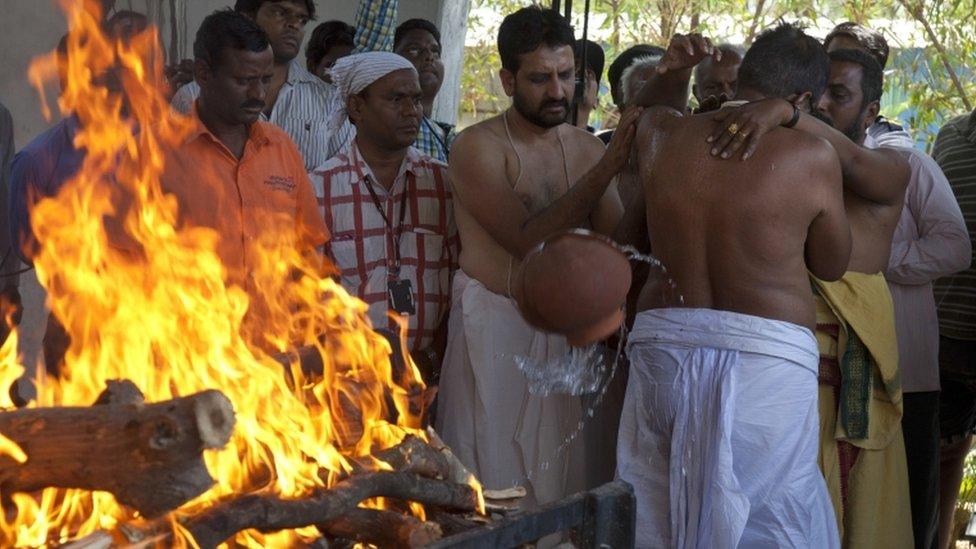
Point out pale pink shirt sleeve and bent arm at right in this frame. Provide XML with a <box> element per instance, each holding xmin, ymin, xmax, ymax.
<box><xmin>885</xmin><ymin>155</ymin><xmax>972</xmax><ymax>284</ymax></box>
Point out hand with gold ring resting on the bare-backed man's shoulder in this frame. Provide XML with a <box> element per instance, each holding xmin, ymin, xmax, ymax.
<box><xmin>707</xmin><ymin>98</ymin><xmax>793</xmax><ymax>160</ymax></box>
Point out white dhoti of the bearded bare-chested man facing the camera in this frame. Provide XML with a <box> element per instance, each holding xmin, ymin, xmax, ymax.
<box><xmin>437</xmin><ymin>271</ymin><xmax>583</xmax><ymax>507</ymax></box>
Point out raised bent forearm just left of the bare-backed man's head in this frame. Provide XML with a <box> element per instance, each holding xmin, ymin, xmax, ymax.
<box><xmin>634</xmin><ymin>34</ymin><xmax>722</xmax><ymax>112</ymax></box>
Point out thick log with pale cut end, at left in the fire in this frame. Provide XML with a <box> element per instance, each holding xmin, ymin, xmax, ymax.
<box><xmin>0</xmin><ymin>382</ymin><xmax>234</xmax><ymax>517</ymax></box>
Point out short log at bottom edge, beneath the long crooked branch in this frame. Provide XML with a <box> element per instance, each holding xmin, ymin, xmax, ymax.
<box><xmin>319</xmin><ymin>508</ymin><xmax>443</xmax><ymax>548</ymax></box>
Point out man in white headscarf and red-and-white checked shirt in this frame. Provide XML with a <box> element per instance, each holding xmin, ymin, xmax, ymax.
<box><xmin>312</xmin><ymin>52</ymin><xmax>458</xmax><ymax>383</ymax></box>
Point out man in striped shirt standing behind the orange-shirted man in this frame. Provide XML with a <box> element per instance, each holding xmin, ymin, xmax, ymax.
<box><xmin>172</xmin><ymin>0</ymin><xmax>352</xmax><ymax>171</ymax></box>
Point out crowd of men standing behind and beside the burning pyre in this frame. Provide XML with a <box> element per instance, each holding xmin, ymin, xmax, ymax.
<box><xmin>0</xmin><ymin>0</ymin><xmax>976</xmax><ymax>548</ymax></box>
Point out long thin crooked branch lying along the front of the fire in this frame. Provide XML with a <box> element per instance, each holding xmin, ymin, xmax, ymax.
<box><xmin>185</xmin><ymin>472</ymin><xmax>478</xmax><ymax>549</ymax></box>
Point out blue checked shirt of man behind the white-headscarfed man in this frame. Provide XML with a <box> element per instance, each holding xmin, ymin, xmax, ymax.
<box><xmin>355</xmin><ymin>0</ymin><xmax>456</xmax><ymax>162</ymax></box>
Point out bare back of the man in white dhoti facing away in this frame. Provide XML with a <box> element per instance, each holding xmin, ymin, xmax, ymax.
<box><xmin>637</xmin><ymin>107</ymin><xmax>851</xmax><ymax>330</ymax></box>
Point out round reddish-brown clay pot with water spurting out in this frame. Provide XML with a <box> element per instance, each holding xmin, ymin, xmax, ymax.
<box><xmin>512</xmin><ymin>229</ymin><xmax>631</xmax><ymax>346</ymax></box>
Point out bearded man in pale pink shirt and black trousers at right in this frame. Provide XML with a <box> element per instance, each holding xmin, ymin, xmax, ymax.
<box><xmin>820</xmin><ymin>49</ymin><xmax>971</xmax><ymax>548</ymax></box>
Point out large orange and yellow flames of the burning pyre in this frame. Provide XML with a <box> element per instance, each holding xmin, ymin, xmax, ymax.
<box><xmin>0</xmin><ymin>0</ymin><xmax>472</xmax><ymax>547</ymax></box>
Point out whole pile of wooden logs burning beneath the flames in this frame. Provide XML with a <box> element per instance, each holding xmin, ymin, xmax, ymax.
<box><xmin>0</xmin><ymin>381</ymin><xmax>488</xmax><ymax>548</ymax></box>
